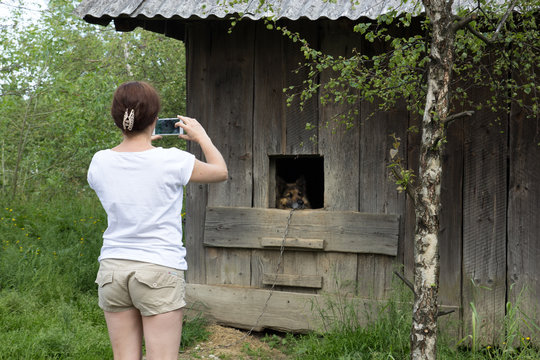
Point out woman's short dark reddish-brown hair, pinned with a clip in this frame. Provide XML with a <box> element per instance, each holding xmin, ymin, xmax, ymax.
<box><xmin>111</xmin><ymin>81</ymin><xmax>161</xmax><ymax>134</ymax></box>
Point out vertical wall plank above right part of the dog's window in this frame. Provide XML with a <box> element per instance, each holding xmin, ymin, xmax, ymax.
<box><xmin>282</xmin><ymin>20</ymin><xmax>319</xmax><ymax>155</ymax></box>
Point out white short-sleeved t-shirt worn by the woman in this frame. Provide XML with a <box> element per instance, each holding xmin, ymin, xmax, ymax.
<box><xmin>88</xmin><ymin>148</ymin><xmax>195</xmax><ymax>270</ymax></box>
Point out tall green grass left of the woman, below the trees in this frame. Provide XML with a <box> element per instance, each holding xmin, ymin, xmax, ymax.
<box><xmin>0</xmin><ymin>192</ymin><xmax>207</xmax><ymax>360</ymax></box>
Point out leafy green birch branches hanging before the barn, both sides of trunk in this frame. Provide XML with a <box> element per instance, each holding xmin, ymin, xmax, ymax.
<box><xmin>246</xmin><ymin>0</ymin><xmax>540</xmax><ymax>129</ymax></box>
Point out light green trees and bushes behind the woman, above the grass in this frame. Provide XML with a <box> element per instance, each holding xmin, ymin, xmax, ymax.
<box><xmin>0</xmin><ymin>0</ymin><xmax>185</xmax><ymax>198</ymax></box>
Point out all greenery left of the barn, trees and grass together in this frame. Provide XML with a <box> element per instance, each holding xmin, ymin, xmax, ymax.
<box><xmin>0</xmin><ymin>0</ymin><xmax>198</xmax><ymax>359</ymax></box>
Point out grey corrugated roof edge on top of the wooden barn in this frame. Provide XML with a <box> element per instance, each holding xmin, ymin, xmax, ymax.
<box><xmin>75</xmin><ymin>0</ymin><xmax>484</xmax><ymax>20</ymax></box>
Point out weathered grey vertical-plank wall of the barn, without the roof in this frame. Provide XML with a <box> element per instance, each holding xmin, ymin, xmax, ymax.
<box><xmin>185</xmin><ymin>20</ymin><xmax>540</xmax><ymax>341</ymax></box>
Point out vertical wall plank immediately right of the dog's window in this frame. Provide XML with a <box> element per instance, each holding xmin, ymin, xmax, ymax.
<box><xmin>318</xmin><ymin>20</ymin><xmax>361</xmax><ymax>293</ymax></box>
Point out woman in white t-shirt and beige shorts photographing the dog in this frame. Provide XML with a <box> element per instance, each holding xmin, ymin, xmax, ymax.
<box><xmin>88</xmin><ymin>82</ymin><xmax>228</xmax><ymax>360</ymax></box>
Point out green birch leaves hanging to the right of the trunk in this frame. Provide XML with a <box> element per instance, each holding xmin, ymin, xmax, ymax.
<box><xmin>454</xmin><ymin>0</ymin><xmax>540</xmax><ymax>118</ymax></box>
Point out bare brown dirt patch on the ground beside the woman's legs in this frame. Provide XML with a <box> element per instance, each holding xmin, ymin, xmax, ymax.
<box><xmin>178</xmin><ymin>325</ymin><xmax>288</xmax><ymax>360</ymax></box>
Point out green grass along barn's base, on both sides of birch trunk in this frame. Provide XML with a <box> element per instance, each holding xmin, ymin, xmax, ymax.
<box><xmin>278</xmin><ymin>274</ymin><xmax>540</xmax><ymax>360</ymax></box>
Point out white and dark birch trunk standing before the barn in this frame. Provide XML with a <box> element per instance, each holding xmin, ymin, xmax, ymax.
<box><xmin>411</xmin><ymin>0</ymin><xmax>454</xmax><ymax>360</ymax></box>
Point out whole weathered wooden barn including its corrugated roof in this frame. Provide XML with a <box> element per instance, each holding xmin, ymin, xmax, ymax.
<box><xmin>76</xmin><ymin>0</ymin><xmax>540</xmax><ymax>341</ymax></box>
